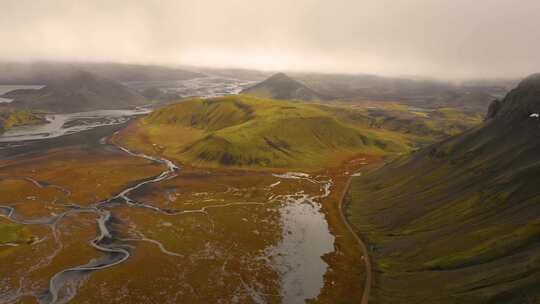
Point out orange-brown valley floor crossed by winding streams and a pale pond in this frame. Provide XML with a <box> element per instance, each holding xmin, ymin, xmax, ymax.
<box><xmin>0</xmin><ymin>125</ymin><xmax>371</xmax><ymax>303</ymax></box>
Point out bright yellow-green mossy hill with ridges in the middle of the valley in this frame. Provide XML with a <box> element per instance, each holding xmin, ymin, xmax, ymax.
<box><xmin>143</xmin><ymin>95</ymin><xmax>407</xmax><ymax>168</ymax></box>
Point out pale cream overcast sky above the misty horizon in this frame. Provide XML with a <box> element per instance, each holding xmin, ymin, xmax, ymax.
<box><xmin>0</xmin><ymin>0</ymin><xmax>540</xmax><ymax>78</ymax></box>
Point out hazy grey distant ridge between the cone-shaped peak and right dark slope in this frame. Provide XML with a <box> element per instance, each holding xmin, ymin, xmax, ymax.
<box><xmin>292</xmin><ymin>73</ymin><xmax>506</xmax><ymax>113</ymax></box>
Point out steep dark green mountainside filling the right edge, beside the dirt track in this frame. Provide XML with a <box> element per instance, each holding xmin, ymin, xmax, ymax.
<box><xmin>347</xmin><ymin>75</ymin><xmax>540</xmax><ymax>303</ymax></box>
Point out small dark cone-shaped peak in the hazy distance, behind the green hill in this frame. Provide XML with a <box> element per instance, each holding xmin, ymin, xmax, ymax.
<box><xmin>242</xmin><ymin>73</ymin><xmax>322</xmax><ymax>101</ymax></box>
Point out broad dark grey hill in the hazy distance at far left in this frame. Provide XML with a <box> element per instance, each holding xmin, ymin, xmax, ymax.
<box><xmin>3</xmin><ymin>72</ymin><xmax>146</xmax><ymax>113</ymax></box>
